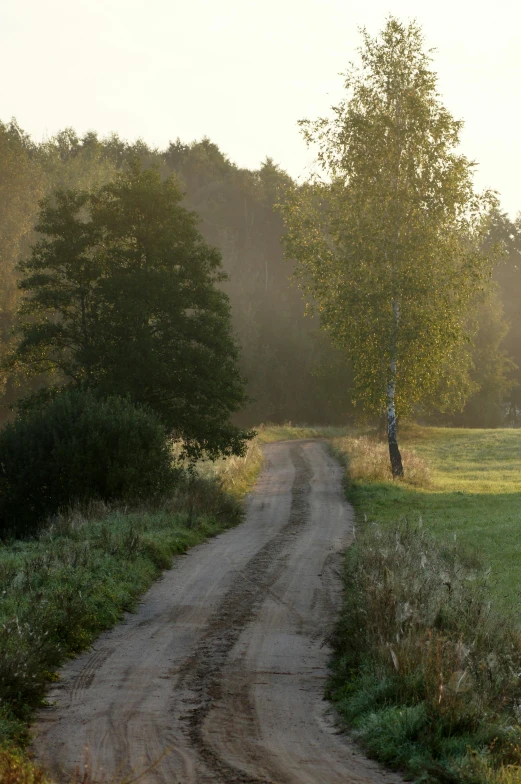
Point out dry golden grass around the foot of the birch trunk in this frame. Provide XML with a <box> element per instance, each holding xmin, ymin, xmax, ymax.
<box><xmin>332</xmin><ymin>435</ymin><xmax>431</xmax><ymax>487</ymax></box>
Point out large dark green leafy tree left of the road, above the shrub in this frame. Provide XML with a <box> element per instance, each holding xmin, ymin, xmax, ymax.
<box><xmin>11</xmin><ymin>162</ymin><xmax>249</xmax><ymax>458</ymax></box>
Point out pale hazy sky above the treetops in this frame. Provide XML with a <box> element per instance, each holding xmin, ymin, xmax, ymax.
<box><xmin>0</xmin><ymin>0</ymin><xmax>521</xmax><ymax>215</ymax></box>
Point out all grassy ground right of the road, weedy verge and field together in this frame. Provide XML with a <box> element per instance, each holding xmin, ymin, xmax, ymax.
<box><xmin>330</xmin><ymin>427</ymin><xmax>521</xmax><ymax>784</ymax></box>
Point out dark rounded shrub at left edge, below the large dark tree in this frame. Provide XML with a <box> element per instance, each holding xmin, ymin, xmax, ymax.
<box><xmin>0</xmin><ymin>390</ymin><xmax>176</xmax><ymax>536</ymax></box>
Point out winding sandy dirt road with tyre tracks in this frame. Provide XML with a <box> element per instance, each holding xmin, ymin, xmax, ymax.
<box><xmin>34</xmin><ymin>441</ymin><xmax>399</xmax><ymax>784</ymax></box>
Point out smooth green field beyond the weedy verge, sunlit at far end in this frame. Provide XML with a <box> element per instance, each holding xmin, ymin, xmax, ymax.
<box><xmin>333</xmin><ymin>426</ymin><xmax>521</xmax><ymax>618</ymax></box>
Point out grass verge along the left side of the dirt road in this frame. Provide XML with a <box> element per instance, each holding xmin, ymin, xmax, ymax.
<box><xmin>0</xmin><ymin>442</ymin><xmax>262</xmax><ymax>772</ymax></box>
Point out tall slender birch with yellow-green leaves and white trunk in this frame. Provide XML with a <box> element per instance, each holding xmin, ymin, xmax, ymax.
<box><xmin>282</xmin><ymin>17</ymin><xmax>495</xmax><ymax>477</ymax></box>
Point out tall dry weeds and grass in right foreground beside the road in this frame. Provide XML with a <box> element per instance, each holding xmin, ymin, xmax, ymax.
<box><xmin>331</xmin><ymin>524</ymin><xmax>521</xmax><ymax>784</ymax></box>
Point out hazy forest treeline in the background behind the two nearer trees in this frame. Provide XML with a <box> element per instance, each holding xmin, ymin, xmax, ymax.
<box><xmin>0</xmin><ymin>115</ymin><xmax>521</xmax><ymax>427</ymax></box>
